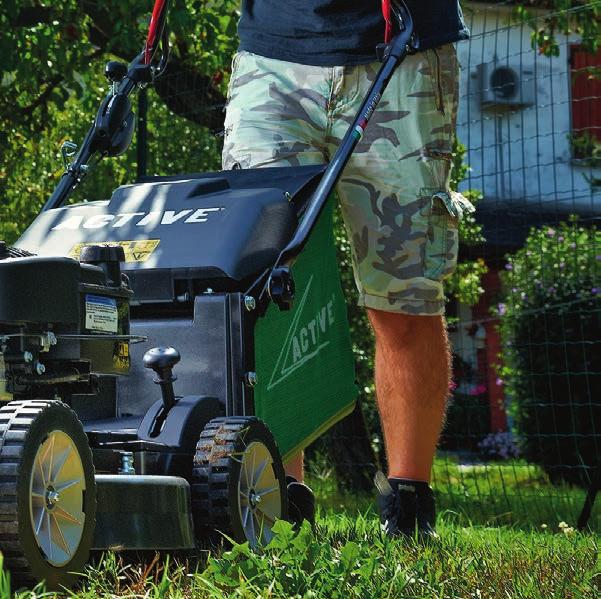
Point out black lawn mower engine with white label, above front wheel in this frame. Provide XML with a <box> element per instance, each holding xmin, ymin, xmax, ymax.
<box><xmin>0</xmin><ymin>242</ymin><xmax>133</xmax><ymax>406</ymax></box>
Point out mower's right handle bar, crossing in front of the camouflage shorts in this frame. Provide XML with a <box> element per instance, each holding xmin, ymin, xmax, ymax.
<box><xmin>276</xmin><ymin>0</ymin><xmax>419</xmax><ymax>266</ymax></box>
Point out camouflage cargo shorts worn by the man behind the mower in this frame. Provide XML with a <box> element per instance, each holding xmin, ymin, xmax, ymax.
<box><xmin>223</xmin><ymin>45</ymin><xmax>472</xmax><ymax>314</ymax></box>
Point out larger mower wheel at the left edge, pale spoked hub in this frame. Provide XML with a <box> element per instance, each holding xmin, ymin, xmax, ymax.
<box><xmin>0</xmin><ymin>400</ymin><xmax>96</xmax><ymax>590</ymax></box>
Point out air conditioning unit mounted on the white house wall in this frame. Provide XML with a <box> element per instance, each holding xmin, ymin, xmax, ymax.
<box><xmin>478</xmin><ymin>63</ymin><xmax>536</xmax><ymax>109</ymax></box>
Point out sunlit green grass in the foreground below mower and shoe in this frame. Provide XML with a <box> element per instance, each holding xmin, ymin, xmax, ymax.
<box><xmin>0</xmin><ymin>478</ymin><xmax>601</xmax><ymax>599</ymax></box>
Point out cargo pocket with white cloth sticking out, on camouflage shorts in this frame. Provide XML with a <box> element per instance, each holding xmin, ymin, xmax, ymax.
<box><xmin>424</xmin><ymin>191</ymin><xmax>475</xmax><ymax>281</ymax></box>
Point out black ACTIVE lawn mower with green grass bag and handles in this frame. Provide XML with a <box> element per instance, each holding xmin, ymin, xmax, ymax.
<box><xmin>0</xmin><ymin>0</ymin><xmax>417</xmax><ymax>589</ymax></box>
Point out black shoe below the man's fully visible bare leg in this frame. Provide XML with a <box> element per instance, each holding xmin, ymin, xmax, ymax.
<box><xmin>375</xmin><ymin>472</ymin><xmax>438</xmax><ymax>540</ymax></box>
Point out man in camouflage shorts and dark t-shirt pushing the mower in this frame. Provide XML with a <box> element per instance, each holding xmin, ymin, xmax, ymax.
<box><xmin>223</xmin><ymin>0</ymin><xmax>468</xmax><ymax>536</ymax></box>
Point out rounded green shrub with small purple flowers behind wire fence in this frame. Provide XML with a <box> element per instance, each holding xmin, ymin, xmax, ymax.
<box><xmin>497</xmin><ymin>217</ymin><xmax>601</xmax><ymax>486</ymax></box>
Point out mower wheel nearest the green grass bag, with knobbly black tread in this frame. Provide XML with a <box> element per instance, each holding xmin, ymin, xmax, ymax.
<box><xmin>191</xmin><ymin>417</ymin><xmax>288</xmax><ymax>548</ymax></box>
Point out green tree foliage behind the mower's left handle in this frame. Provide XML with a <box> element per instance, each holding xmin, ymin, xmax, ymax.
<box><xmin>0</xmin><ymin>0</ymin><xmax>238</xmax><ymax>242</ymax></box>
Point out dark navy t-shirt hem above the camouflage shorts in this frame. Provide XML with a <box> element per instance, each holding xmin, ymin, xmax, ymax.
<box><xmin>238</xmin><ymin>0</ymin><xmax>469</xmax><ymax>66</ymax></box>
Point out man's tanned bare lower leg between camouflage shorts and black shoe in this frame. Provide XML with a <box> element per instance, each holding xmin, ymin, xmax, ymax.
<box><xmin>368</xmin><ymin>309</ymin><xmax>450</xmax><ymax>482</ymax></box>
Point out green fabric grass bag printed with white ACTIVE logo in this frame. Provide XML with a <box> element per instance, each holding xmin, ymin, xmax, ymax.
<box><xmin>255</xmin><ymin>201</ymin><xmax>357</xmax><ymax>459</ymax></box>
